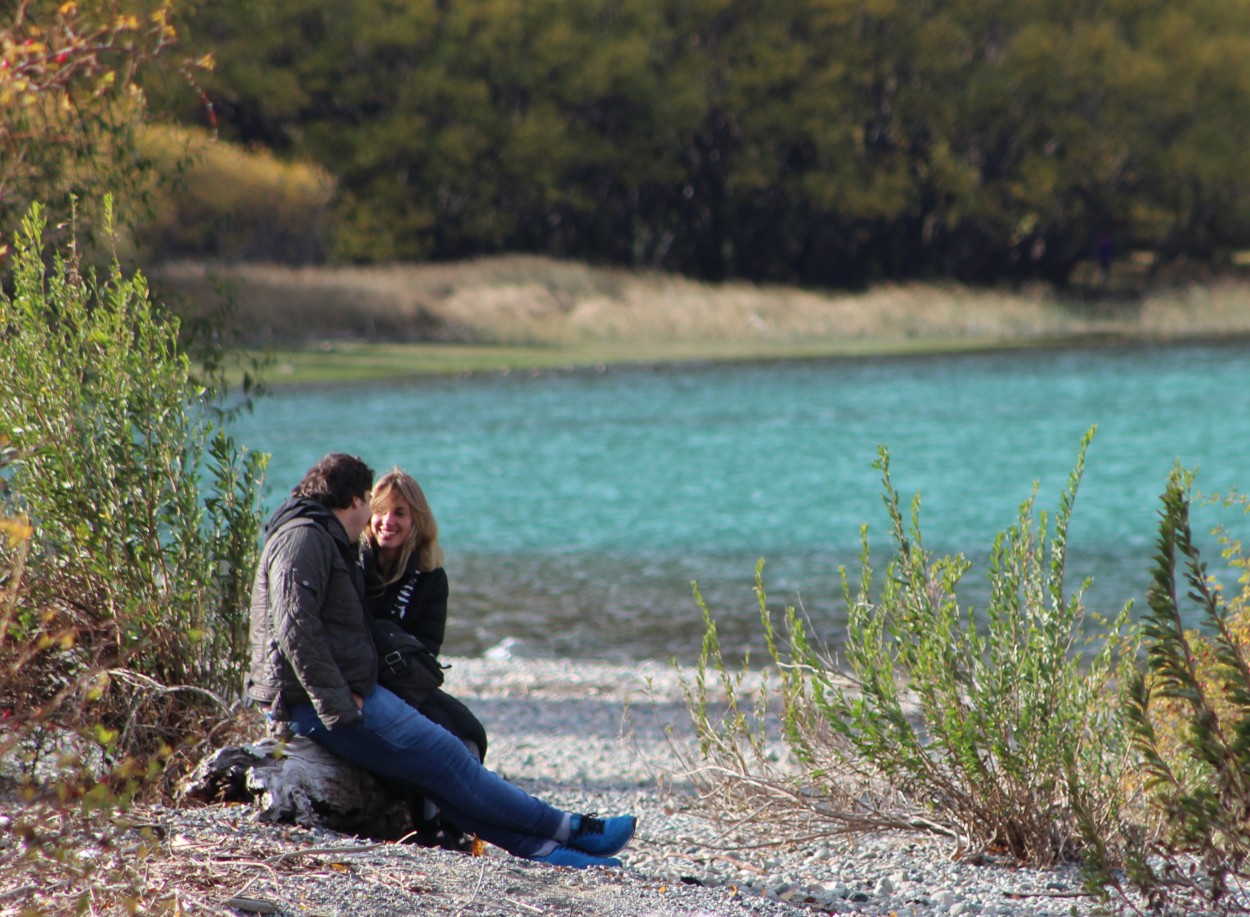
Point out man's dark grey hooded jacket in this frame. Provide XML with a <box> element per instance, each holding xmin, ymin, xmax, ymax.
<box><xmin>245</xmin><ymin>497</ymin><xmax>378</xmax><ymax>730</ymax></box>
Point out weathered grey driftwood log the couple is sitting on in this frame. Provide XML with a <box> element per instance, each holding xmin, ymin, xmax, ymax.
<box><xmin>179</xmin><ymin>736</ymin><xmax>420</xmax><ymax>841</ymax></box>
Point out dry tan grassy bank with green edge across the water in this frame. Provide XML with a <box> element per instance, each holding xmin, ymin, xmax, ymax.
<box><xmin>149</xmin><ymin>256</ymin><xmax>1250</xmax><ymax>384</ymax></box>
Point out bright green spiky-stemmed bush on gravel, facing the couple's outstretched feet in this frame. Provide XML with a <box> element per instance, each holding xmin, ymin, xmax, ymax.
<box><xmin>688</xmin><ymin>430</ymin><xmax>1134</xmax><ymax>865</ymax></box>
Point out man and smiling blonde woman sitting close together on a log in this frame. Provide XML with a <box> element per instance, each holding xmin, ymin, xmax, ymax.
<box><xmin>246</xmin><ymin>452</ymin><xmax>636</xmax><ymax>868</ymax></box>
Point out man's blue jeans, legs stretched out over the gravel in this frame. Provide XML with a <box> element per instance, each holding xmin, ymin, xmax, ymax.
<box><xmin>290</xmin><ymin>685</ymin><xmax>565</xmax><ymax>857</ymax></box>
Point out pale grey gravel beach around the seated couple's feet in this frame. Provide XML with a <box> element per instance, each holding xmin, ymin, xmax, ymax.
<box><xmin>0</xmin><ymin>658</ymin><xmax>1115</xmax><ymax>917</ymax></box>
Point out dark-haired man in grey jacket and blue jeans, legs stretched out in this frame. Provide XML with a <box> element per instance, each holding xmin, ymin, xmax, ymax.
<box><xmin>246</xmin><ymin>452</ymin><xmax>636</xmax><ymax>868</ymax></box>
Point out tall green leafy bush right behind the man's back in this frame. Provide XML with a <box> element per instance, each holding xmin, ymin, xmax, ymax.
<box><xmin>0</xmin><ymin>206</ymin><xmax>265</xmax><ymax>784</ymax></box>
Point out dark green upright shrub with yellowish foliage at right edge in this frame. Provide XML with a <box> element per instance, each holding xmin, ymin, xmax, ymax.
<box><xmin>1090</xmin><ymin>468</ymin><xmax>1250</xmax><ymax>915</ymax></box>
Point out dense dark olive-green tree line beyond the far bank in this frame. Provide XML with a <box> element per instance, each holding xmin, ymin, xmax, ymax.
<box><xmin>149</xmin><ymin>0</ymin><xmax>1250</xmax><ymax>285</ymax></box>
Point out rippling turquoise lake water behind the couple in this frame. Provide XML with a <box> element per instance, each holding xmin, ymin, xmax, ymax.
<box><xmin>233</xmin><ymin>345</ymin><xmax>1250</xmax><ymax>662</ymax></box>
